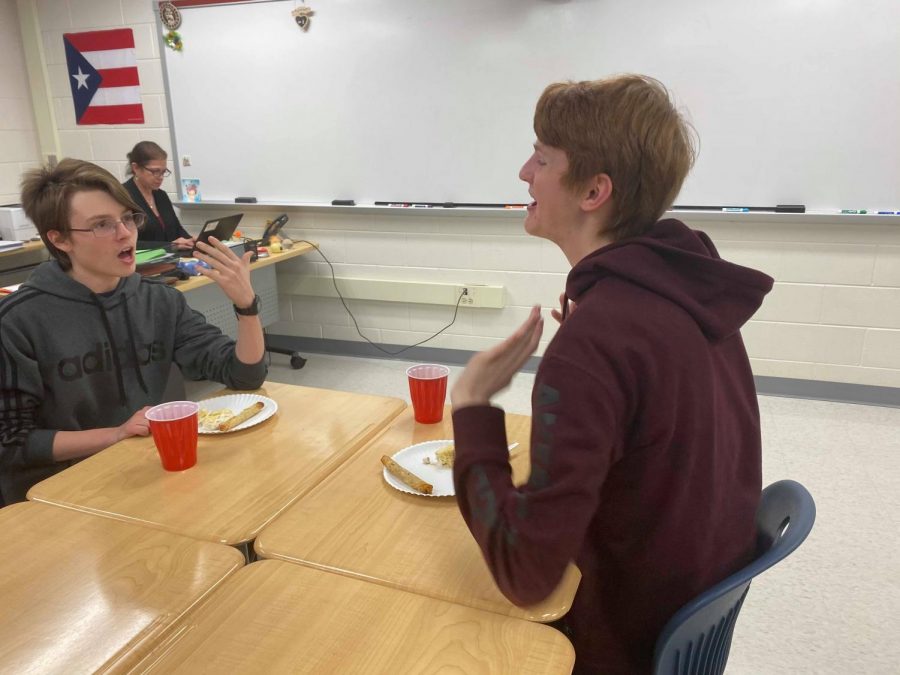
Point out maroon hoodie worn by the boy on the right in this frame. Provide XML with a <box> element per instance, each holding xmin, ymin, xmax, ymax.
<box><xmin>453</xmin><ymin>220</ymin><xmax>772</xmax><ymax>673</ymax></box>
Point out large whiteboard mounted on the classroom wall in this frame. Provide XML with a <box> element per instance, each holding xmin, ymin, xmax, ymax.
<box><xmin>161</xmin><ymin>0</ymin><xmax>900</xmax><ymax>209</ymax></box>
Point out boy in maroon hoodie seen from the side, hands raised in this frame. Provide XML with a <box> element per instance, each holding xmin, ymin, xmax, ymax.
<box><xmin>451</xmin><ymin>75</ymin><xmax>772</xmax><ymax>673</ymax></box>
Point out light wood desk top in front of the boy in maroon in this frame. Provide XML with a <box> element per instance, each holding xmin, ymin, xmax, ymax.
<box><xmin>255</xmin><ymin>408</ymin><xmax>581</xmax><ymax>622</ymax></box>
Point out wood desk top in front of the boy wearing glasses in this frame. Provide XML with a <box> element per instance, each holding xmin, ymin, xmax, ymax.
<box><xmin>28</xmin><ymin>383</ymin><xmax>406</xmax><ymax>545</ymax></box>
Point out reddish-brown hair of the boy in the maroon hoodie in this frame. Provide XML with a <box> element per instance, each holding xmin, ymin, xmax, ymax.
<box><xmin>534</xmin><ymin>75</ymin><xmax>696</xmax><ymax>240</ymax></box>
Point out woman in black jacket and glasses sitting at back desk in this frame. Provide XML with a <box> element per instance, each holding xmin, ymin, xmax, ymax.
<box><xmin>124</xmin><ymin>141</ymin><xmax>194</xmax><ymax>249</ymax></box>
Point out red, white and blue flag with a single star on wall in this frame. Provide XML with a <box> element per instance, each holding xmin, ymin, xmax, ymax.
<box><xmin>63</xmin><ymin>28</ymin><xmax>144</xmax><ymax>124</ymax></box>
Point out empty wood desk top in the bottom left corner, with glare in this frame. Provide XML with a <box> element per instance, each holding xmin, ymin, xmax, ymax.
<box><xmin>0</xmin><ymin>502</ymin><xmax>244</xmax><ymax>675</ymax></box>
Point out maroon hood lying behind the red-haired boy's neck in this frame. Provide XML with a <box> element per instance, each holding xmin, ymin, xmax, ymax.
<box><xmin>563</xmin><ymin>219</ymin><xmax>773</xmax><ymax>341</ymax></box>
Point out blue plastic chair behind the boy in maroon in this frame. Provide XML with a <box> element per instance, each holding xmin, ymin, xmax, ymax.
<box><xmin>653</xmin><ymin>480</ymin><xmax>816</xmax><ymax>675</ymax></box>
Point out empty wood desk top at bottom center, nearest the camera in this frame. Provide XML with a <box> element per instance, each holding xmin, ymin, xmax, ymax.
<box><xmin>140</xmin><ymin>560</ymin><xmax>575</xmax><ymax>675</ymax></box>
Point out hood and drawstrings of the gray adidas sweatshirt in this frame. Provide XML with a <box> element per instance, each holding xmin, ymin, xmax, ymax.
<box><xmin>22</xmin><ymin>260</ymin><xmax>148</xmax><ymax>405</ymax></box>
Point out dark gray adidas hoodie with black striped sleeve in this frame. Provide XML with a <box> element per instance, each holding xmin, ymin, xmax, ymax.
<box><xmin>0</xmin><ymin>261</ymin><xmax>267</xmax><ymax>504</ymax></box>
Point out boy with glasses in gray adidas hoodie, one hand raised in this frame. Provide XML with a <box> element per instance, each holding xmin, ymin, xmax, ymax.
<box><xmin>0</xmin><ymin>159</ymin><xmax>267</xmax><ymax>504</ymax></box>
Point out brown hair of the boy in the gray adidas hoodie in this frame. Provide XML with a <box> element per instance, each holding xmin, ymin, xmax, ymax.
<box><xmin>22</xmin><ymin>158</ymin><xmax>141</xmax><ymax>270</ymax></box>
